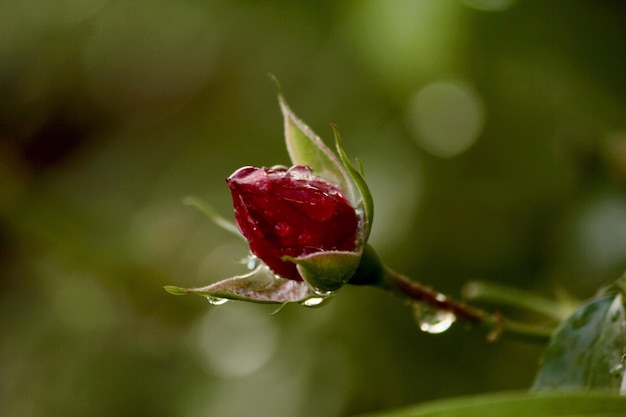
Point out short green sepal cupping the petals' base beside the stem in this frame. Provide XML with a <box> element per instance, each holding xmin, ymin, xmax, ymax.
<box><xmin>283</xmin><ymin>251</ymin><xmax>361</xmax><ymax>294</ymax></box>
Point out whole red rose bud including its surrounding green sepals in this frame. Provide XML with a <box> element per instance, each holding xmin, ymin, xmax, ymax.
<box><xmin>165</xmin><ymin>88</ymin><xmax>372</xmax><ymax>307</ymax></box>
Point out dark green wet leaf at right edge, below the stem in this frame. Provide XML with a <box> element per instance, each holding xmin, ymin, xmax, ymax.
<box><xmin>532</xmin><ymin>294</ymin><xmax>626</xmax><ymax>393</ymax></box>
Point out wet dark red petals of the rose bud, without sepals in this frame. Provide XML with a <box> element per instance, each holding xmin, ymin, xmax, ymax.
<box><xmin>226</xmin><ymin>166</ymin><xmax>359</xmax><ymax>281</ymax></box>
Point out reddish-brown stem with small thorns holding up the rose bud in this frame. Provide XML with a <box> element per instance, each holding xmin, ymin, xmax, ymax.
<box><xmin>384</xmin><ymin>268</ymin><xmax>552</xmax><ymax>343</ymax></box>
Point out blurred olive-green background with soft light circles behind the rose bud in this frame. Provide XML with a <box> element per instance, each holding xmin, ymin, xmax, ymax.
<box><xmin>0</xmin><ymin>0</ymin><xmax>626</xmax><ymax>417</ymax></box>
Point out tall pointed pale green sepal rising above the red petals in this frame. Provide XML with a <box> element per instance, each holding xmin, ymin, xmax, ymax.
<box><xmin>273</xmin><ymin>78</ymin><xmax>355</xmax><ymax>201</ymax></box>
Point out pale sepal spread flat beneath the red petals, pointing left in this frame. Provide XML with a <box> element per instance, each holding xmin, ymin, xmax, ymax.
<box><xmin>164</xmin><ymin>265</ymin><xmax>319</xmax><ymax>304</ymax></box>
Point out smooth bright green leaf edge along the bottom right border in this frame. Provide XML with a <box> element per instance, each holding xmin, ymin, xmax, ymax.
<box><xmin>354</xmin><ymin>391</ymin><xmax>626</xmax><ymax>417</ymax></box>
